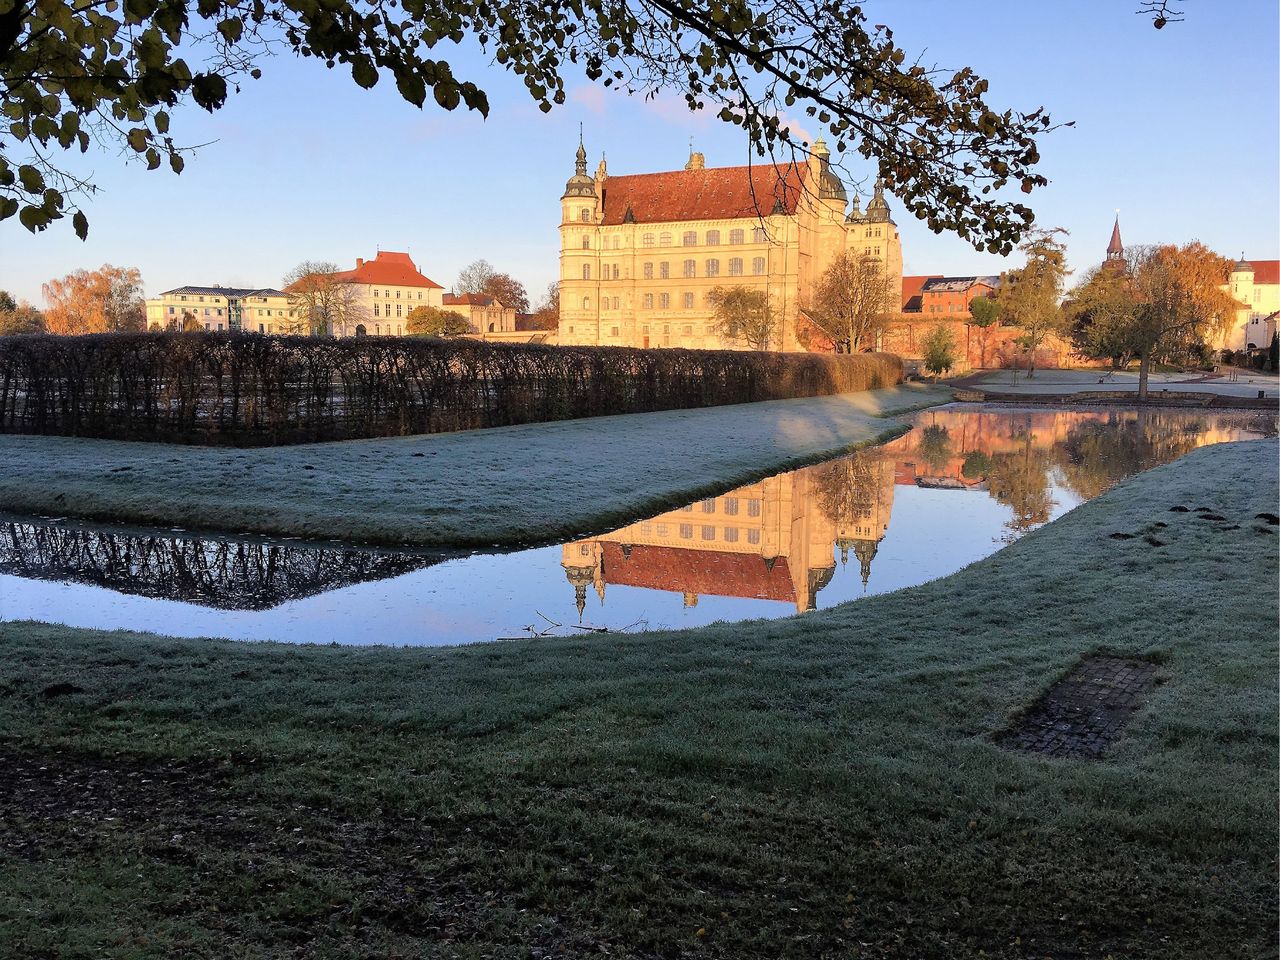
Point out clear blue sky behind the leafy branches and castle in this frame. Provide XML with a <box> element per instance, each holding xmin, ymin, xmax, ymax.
<box><xmin>0</xmin><ymin>0</ymin><xmax>1280</xmax><ymax>303</ymax></box>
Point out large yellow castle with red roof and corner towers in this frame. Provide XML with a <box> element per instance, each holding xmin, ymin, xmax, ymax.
<box><xmin>559</xmin><ymin>140</ymin><xmax>902</xmax><ymax>351</ymax></box>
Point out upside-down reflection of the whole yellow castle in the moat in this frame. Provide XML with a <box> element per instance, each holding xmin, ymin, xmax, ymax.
<box><xmin>562</xmin><ymin>451</ymin><xmax>893</xmax><ymax>613</ymax></box>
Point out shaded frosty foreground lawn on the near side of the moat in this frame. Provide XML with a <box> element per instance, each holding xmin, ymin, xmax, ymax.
<box><xmin>0</xmin><ymin>442</ymin><xmax>1280</xmax><ymax>960</ymax></box>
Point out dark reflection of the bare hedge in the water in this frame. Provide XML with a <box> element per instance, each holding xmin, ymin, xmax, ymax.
<box><xmin>0</xmin><ymin>520</ymin><xmax>443</xmax><ymax>611</ymax></box>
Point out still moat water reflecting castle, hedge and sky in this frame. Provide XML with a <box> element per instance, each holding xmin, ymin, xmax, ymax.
<box><xmin>0</xmin><ymin>404</ymin><xmax>1275</xmax><ymax>645</ymax></box>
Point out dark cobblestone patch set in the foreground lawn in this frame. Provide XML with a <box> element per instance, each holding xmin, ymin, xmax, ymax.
<box><xmin>996</xmin><ymin>657</ymin><xmax>1156</xmax><ymax>759</ymax></box>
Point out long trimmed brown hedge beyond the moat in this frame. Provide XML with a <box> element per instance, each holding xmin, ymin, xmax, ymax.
<box><xmin>0</xmin><ymin>333</ymin><xmax>902</xmax><ymax>445</ymax></box>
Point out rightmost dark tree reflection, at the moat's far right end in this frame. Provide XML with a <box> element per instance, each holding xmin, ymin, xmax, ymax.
<box><xmin>1053</xmin><ymin>410</ymin><xmax>1208</xmax><ymax>499</ymax></box>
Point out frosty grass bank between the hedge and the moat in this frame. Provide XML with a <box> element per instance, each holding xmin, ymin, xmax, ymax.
<box><xmin>0</xmin><ymin>385</ymin><xmax>951</xmax><ymax>547</ymax></box>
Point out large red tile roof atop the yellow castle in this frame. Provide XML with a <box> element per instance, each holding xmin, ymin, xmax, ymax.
<box><xmin>602</xmin><ymin>164</ymin><xmax>809</xmax><ymax>225</ymax></box>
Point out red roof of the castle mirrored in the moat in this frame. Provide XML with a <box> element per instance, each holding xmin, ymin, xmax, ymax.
<box><xmin>603</xmin><ymin>540</ymin><xmax>796</xmax><ymax>603</ymax></box>
